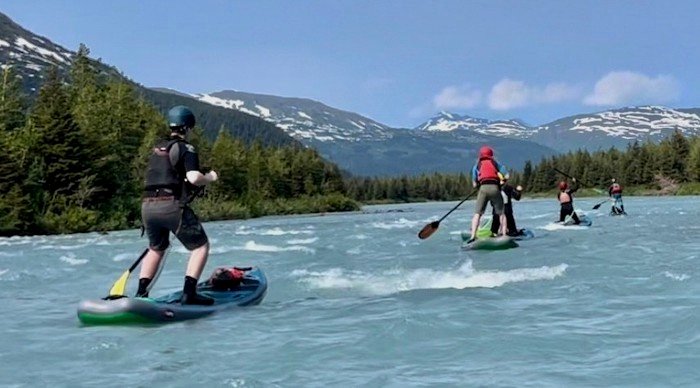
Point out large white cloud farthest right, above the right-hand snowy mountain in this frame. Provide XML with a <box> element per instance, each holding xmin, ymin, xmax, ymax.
<box><xmin>583</xmin><ymin>71</ymin><xmax>680</xmax><ymax>105</ymax></box>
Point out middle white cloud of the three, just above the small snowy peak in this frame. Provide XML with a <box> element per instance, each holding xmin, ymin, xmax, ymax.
<box><xmin>488</xmin><ymin>78</ymin><xmax>580</xmax><ymax>110</ymax></box>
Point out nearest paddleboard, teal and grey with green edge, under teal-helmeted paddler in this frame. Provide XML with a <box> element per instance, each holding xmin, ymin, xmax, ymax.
<box><xmin>78</xmin><ymin>267</ymin><xmax>267</xmax><ymax>325</ymax></box>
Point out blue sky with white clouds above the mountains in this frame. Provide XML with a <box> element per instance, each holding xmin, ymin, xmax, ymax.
<box><xmin>0</xmin><ymin>0</ymin><xmax>700</xmax><ymax>127</ymax></box>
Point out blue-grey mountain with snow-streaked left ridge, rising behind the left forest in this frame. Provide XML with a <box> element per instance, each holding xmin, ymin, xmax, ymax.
<box><xmin>195</xmin><ymin>91</ymin><xmax>554</xmax><ymax>175</ymax></box>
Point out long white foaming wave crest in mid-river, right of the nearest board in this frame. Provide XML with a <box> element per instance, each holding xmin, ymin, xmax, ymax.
<box><xmin>291</xmin><ymin>261</ymin><xmax>568</xmax><ymax>295</ymax></box>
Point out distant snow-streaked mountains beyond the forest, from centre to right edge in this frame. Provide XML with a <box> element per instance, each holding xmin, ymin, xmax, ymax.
<box><xmin>194</xmin><ymin>90</ymin><xmax>700</xmax><ymax>175</ymax></box>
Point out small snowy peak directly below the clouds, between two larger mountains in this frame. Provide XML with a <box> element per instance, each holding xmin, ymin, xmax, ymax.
<box><xmin>416</xmin><ymin>112</ymin><xmax>536</xmax><ymax>139</ymax></box>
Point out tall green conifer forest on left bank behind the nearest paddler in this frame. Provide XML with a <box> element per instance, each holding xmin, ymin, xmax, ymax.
<box><xmin>0</xmin><ymin>46</ymin><xmax>358</xmax><ymax>235</ymax></box>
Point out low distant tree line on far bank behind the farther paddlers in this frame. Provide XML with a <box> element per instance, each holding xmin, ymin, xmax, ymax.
<box><xmin>347</xmin><ymin>131</ymin><xmax>700</xmax><ymax>202</ymax></box>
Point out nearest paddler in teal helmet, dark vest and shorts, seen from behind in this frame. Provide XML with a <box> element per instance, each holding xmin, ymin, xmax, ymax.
<box><xmin>129</xmin><ymin>106</ymin><xmax>218</xmax><ymax>305</ymax></box>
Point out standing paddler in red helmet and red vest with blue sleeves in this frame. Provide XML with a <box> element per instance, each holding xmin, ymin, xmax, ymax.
<box><xmin>467</xmin><ymin>146</ymin><xmax>508</xmax><ymax>243</ymax></box>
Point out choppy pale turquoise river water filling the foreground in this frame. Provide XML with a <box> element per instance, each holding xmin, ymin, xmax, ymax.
<box><xmin>0</xmin><ymin>197</ymin><xmax>700</xmax><ymax>387</ymax></box>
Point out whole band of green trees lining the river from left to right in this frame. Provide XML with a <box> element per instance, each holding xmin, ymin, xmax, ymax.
<box><xmin>0</xmin><ymin>45</ymin><xmax>700</xmax><ymax>236</ymax></box>
